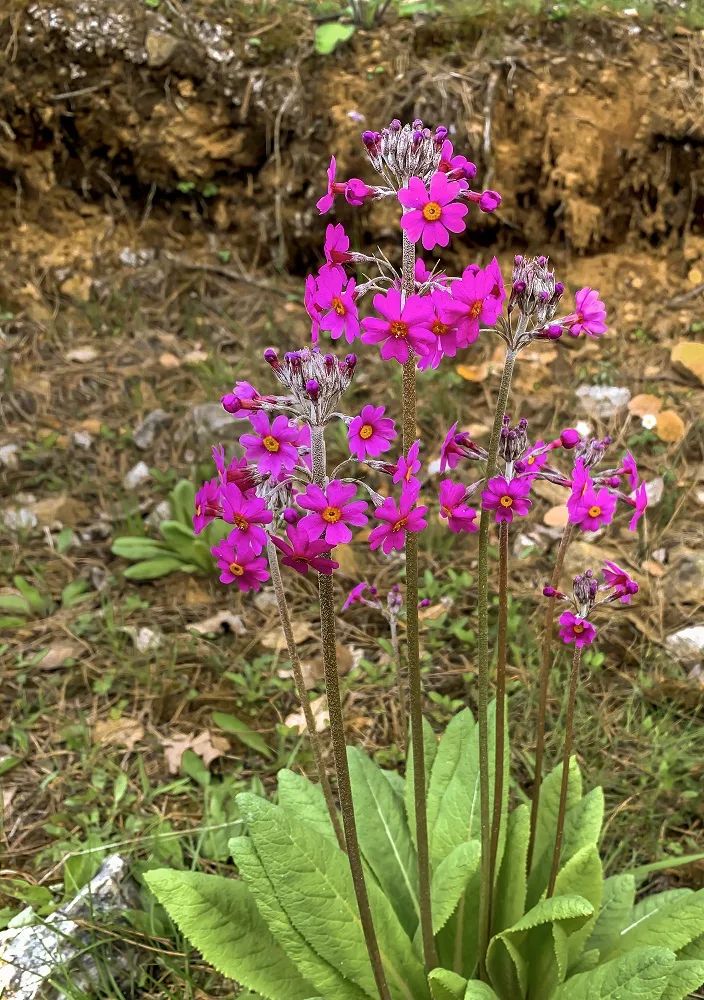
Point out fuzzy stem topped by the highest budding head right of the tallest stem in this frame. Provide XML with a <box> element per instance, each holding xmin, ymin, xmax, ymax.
<box><xmin>477</xmin><ymin>349</ymin><xmax>516</xmax><ymax>979</ymax></box>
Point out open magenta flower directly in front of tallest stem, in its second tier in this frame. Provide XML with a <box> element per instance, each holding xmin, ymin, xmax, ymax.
<box><xmin>362</xmin><ymin>288</ymin><xmax>435</xmax><ymax>365</ymax></box>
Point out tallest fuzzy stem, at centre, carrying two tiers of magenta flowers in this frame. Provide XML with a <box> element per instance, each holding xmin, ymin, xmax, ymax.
<box><xmin>401</xmin><ymin>233</ymin><xmax>438</xmax><ymax>972</ymax></box>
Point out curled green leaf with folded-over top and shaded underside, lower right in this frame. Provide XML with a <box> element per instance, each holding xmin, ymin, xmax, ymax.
<box><xmin>487</xmin><ymin>896</ymin><xmax>594</xmax><ymax>998</ymax></box>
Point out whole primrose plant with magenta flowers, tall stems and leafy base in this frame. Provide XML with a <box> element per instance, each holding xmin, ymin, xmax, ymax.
<box><xmin>147</xmin><ymin>121</ymin><xmax>704</xmax><ymax>1000</ymax></box>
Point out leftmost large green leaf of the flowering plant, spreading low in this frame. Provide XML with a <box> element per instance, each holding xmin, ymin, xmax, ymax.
<box><xmin>144</xmin><ymin>869</ymin><xmax>315</xmax><ymax>1000</ymax></box>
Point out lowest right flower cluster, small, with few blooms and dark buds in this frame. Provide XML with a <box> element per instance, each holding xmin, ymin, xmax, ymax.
<box><xmin>543</xmin><ymin>560</ymin><xmax>638</xmax><ymax>649</ymax></box>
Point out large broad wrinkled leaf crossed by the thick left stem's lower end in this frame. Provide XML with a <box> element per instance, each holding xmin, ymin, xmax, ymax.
<box><xmin>237</xmin><ymin>793</ymin><xmax>428</xmax><ymax>1000</ymax></box>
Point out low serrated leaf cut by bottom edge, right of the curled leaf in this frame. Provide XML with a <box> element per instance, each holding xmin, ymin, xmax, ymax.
<box><xmin>552</xmin><ymin>948</ymin><xmax>675</xmax><ymax>1000</ymax></box>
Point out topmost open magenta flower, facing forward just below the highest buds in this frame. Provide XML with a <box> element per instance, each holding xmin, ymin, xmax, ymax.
<box><xmin>398</xmin><ymin>172</ymin><xmax>469</xmax><ymax>250</ymax></box>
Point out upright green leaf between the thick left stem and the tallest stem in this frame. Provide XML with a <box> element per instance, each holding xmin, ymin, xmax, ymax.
<box><xmin>347</xmin><ymin>747</ymin><xmax>420</xmax><ymax>938</ymax></box>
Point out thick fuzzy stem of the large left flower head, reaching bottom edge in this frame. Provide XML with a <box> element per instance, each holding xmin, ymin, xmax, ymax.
<box><xmin>311</xmin><ymin>427</ymin><xmax>391</xmax><ymax>1000</ymax></box>
